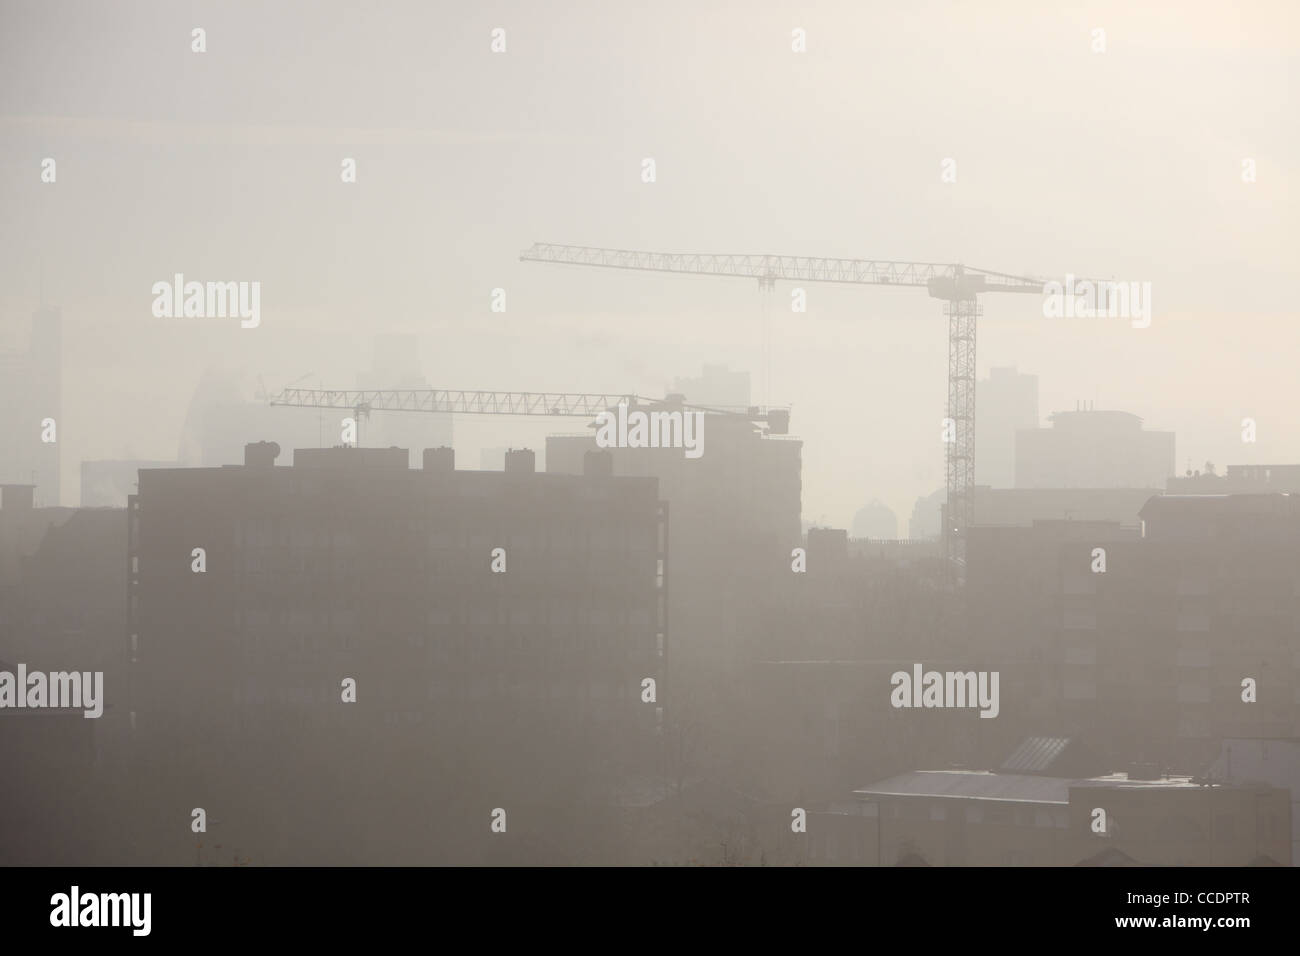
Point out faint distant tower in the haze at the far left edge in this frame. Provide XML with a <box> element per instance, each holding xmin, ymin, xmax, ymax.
<box><xmin>0</xmin><ymin>308</ymin><xmax>64</xmax><ymax>507</ymax></box>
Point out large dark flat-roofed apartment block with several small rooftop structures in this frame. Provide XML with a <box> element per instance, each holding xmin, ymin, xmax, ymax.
<box><xmin>129</xmin><ymin>444</ymin><xmax>668</xmax><ymax>862</ymax></box>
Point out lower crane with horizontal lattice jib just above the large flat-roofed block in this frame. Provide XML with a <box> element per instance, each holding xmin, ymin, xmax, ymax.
<box><xmin>270</xmin><ymin>388</ymin><xmax>790</xmax><ymax>445</ymax></box>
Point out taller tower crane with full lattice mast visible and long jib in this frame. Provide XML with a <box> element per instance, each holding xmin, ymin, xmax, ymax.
<box><xmin>519</xmin><ymin>242</ymin><xmax>1104</xmax><ymax>583</ymax></box>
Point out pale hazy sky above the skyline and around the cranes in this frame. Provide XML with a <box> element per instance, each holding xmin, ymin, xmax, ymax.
<box><xmin>0</xmin><ymin>0</ymin><xmax>1300</xmax><ymax>522</ymax></box>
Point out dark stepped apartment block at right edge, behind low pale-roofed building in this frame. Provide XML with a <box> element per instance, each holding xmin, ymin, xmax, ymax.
<box><xmin>970</xmin><ymin>494</ymin><xmax>1300</xmax><ymax>769</ymax></box>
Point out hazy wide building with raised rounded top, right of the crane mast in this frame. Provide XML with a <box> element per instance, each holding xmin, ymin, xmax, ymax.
<box><xmin>1015</xmin><ymin>408</ymin><xmax>1174</xmax><ymax>488</ymax></box>
